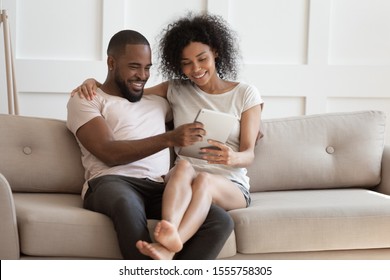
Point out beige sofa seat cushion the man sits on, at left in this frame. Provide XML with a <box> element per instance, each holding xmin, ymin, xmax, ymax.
<box><xmin>14</xmin><ymin>193</ymin><xmax>236</xmax><ymax>259</ymax></box>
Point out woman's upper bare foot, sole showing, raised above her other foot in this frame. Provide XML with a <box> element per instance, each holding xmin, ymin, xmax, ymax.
<box><xmin>154</xmin><ymin>220</ymin><xmax>183</xmax><ymax>253</ymax></box>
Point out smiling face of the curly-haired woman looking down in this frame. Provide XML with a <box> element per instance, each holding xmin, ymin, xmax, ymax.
<box><xmin>181</xmin><ymin>42</ymin><xmax>216</xmax><ymax>86</ymax></box>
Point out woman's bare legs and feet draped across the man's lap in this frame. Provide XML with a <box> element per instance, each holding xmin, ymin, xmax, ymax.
<box><xmin>139</xmin><ymin>161</ymin><xmax>246</xmax><ymax>259</ymax></box>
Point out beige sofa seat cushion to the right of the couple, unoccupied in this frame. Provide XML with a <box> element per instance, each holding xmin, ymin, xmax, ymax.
<box><xmin>230</xmin><ymin>189</ymin><xmax>390</xmax><ymax>254</ymax></box>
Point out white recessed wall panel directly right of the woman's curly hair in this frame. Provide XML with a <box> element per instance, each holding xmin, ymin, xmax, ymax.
<box><xmin>228</xmin><ymin>0</ymin><xmax>309</xmax><ymax>65</ymax></box>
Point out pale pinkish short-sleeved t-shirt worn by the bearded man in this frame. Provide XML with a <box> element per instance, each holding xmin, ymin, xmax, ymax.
<box><xmin>67</xmin><ymin>89</ymin><xmax>172</xmax><ymax>197</ymax></box>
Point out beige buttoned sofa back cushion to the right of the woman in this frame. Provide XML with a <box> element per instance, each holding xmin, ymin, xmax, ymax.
<box><xmin>248</xmin><ymin>111</ymin><xmax>385</xmax><ymax>192</ymax></box>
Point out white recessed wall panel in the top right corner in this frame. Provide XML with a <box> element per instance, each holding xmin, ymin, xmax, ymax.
<box><xmin>329</xmin><ymin>0</ymin><xmax>390</xmax><ymax>65</ymax></box>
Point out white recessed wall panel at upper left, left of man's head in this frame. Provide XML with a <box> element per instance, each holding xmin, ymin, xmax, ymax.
<box><xmin>15</xmin><ymin>0</ymin><xmax>102</xmax><ymax>61</ymax></box>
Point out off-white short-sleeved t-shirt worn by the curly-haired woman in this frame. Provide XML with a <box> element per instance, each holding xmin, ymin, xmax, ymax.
<box><xmin>167</xmin><ymin>81</ymin><xmax>263</xmax><ymax>189</ymax></box>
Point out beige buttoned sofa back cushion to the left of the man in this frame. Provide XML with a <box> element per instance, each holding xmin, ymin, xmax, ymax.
<box><xmin>0</xmin><ymin>115</ymin><xmax>84</xmax><ymax>193</ymax></box>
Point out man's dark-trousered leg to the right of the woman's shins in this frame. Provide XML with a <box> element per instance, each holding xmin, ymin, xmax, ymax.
<box><xmin>175</xmin><ymin>204</ymin><xmax>234</xmax><ymax>260</ymax></box>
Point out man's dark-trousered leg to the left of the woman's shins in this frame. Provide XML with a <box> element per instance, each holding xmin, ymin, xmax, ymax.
<box><xmin>84</xmin><ymin>175</ymin><xmax>162</xmax><ymax>259</ymax></box>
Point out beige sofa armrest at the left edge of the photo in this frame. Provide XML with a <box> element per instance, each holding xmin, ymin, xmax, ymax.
<box><xmin>0</xmin><ymin>173</ymin><xmax>20</xmax><ymax>260</ymax></box>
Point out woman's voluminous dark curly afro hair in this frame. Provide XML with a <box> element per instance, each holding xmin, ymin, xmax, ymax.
<box><xmin>159</xmin><ymin>13</ymin><xmax>240</xmax><ymax>80</ymax></box>
